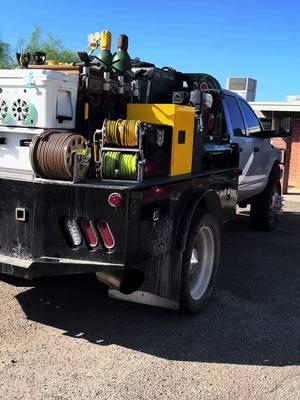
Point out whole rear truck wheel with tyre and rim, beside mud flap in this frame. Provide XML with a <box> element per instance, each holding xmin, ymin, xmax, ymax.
<box><xmin>180</xmin><ymin>210</ymin><xmax>221</xmax><ymax>314</ymax></box>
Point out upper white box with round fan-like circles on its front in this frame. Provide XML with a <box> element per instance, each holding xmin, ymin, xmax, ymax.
<box><xmin>0</xmin><ymin>69</ymin><xmax>78</xmax><ymax>129</ymax></box>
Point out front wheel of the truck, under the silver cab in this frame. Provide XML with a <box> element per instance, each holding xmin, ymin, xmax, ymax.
<box><xmin>250</xmin><ymin>173</ymin><xmax>282</xmax><ymax>231</ymax></box>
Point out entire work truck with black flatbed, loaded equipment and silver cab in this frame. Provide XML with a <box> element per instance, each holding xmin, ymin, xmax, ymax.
<box><xmin>0</xmin><ymin>41</ymin><xmax>288</xmax><ymax>313</ymax></box>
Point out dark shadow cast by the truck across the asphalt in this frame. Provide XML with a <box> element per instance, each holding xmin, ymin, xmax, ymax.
<box><xmin>2</xmin><ymin>212</ymin><xmax>300</xmax><ymax>366</ymax></box>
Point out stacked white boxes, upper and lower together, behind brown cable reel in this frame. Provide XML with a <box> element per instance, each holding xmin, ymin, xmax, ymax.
<box><xmin>0</xmin><ymin>69</ymin><xmax>78</xmax><ymax>173</ymax></box>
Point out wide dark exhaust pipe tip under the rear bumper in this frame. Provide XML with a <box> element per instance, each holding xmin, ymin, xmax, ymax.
<box><xmin>96</xmin><ymin>269</ymin><xmax>144</xmax><ymax>294</ymax></box>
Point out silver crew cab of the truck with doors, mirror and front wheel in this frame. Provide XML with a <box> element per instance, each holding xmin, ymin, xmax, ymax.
<box><xmin>223</xmin><ymin>90</ymin><xmax>285</xmax><ymax>230</ymax></box>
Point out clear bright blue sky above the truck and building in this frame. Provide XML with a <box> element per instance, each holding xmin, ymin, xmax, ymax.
<box><xmin>0</xmin><ymin>0</ymin><xmax>300</xmax><ymax>101</ymax></box>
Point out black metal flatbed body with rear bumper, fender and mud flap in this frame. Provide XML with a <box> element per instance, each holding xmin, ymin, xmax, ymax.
<box><xmin>0</xmin><ymin>164</ymin><xmax>240</xmax><ymax>308</ymax></box>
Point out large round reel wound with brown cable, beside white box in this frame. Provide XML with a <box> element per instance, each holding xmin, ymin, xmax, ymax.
<box><xmin>30</xmin><ymin>131</ymin><xmax>87</xmax><ymax>180</ymax></box>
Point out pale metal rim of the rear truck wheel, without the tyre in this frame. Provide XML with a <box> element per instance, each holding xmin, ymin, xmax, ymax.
<box><xmin>189</xmin><ymin>226</ymin><xmax>215</xmax><ymax>300</ymax></box>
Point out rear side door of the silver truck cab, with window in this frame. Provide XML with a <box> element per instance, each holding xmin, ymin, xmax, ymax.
<box><xmin>224</xmin><ymin>93</ymin><xmax>255</xmax><ymax>201</ymax></box>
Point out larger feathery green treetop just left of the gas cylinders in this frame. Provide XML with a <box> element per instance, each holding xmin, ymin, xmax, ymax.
<box><xmin>22</xmin><ymin>26</ymin><xmax>79</xmax><ymax>63</ymax></box>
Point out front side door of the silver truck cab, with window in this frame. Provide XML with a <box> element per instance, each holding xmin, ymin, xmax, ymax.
<box><xmin>238</xmin><ymin>98</ymin><xmax>273</xmax><ymax>193</ymax></box>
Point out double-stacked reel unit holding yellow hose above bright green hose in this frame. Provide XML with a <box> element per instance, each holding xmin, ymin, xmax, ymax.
<box><xmin>99</xmin><ymin>119</ymin><xmax>172</xmax><ymax>182</ymax></box>
